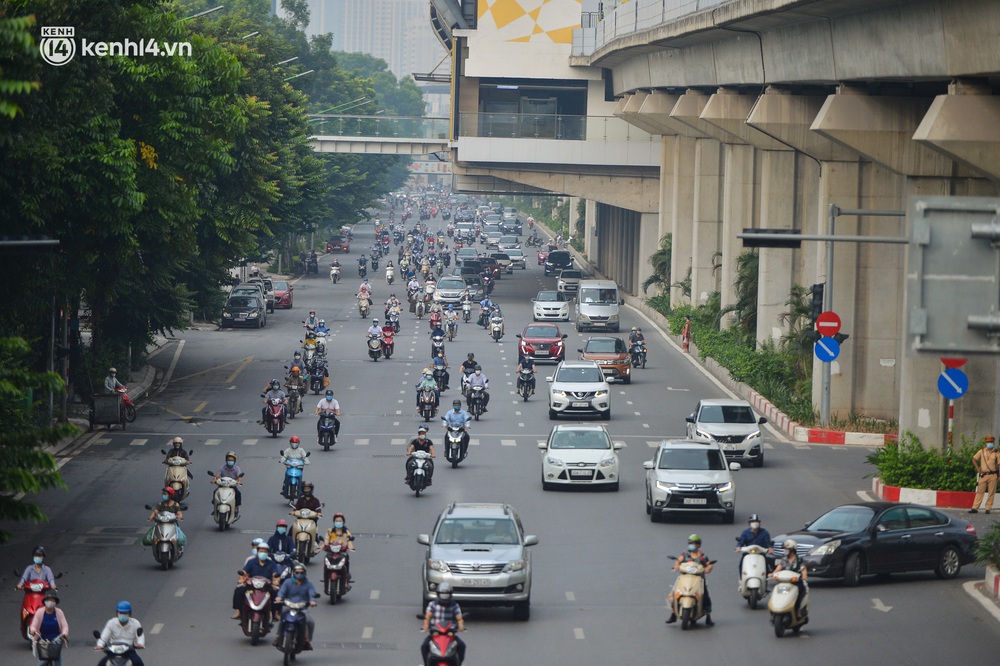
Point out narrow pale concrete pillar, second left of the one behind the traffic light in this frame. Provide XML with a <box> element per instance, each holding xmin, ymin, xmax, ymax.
<box><xmin>691</xmin><ymin>139</ymin><xmax>722</xmax><ymax>305</ymax></box>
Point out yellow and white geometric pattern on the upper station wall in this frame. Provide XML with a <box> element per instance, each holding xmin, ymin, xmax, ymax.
<box><xmin>477</xmin><ymin>0</ymin><xmax>580</xmax><ymax>44</ymax></box>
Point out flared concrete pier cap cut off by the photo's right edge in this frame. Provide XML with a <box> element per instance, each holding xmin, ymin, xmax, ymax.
<box><xmin>913</xmin><ymin>84</ymin><xmax>1000</xmax><ymax>180</ymax></box>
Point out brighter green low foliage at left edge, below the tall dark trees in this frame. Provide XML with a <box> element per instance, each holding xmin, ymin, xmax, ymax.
<box><xmin>0</xmin><ymin>338</ymin><xmax>77</xmax><ymax>543</ymax></box>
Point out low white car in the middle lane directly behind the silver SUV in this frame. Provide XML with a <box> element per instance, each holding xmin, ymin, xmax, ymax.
<box><xmin>538</xmin><ymin>423</ymin><xmax>622</xmax><ymax>490</ymax></box>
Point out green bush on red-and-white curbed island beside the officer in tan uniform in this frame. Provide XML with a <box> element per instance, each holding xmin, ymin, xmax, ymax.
<box><xmin>867</xmin><ymin>432</ymin><xmax>982</xmax><ymax>491</ymax></box>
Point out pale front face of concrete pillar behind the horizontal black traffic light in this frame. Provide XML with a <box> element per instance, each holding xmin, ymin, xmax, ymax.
<box><xmin>757</xmin><ymin>150</ymin><xmax>798</xmax><ymax>342</ymax></box>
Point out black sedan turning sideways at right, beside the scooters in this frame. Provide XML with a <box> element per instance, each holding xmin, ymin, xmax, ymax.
<box><xmin>774</xmin><ymin>502</ymin><xmax>976</xmax><ymax>587</ymax></box>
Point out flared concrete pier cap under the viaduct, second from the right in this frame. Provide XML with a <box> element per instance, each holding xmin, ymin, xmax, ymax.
<box><xmin>811</xmin><ymin>86</ymin><xmax>972</xmax><ymax>177</ymax></box>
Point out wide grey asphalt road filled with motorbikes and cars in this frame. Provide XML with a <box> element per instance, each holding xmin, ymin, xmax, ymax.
<box><xmin>0</xmin><ymin>215</ymin><xmax>1000</xmax><ymax>666</ymax></box>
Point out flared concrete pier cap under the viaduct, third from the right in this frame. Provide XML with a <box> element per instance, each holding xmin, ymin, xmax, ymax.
<box><xmin>747</xmin><ymin>87</ymin><xmax>859</xmax><ymax>162</ymax></box>
